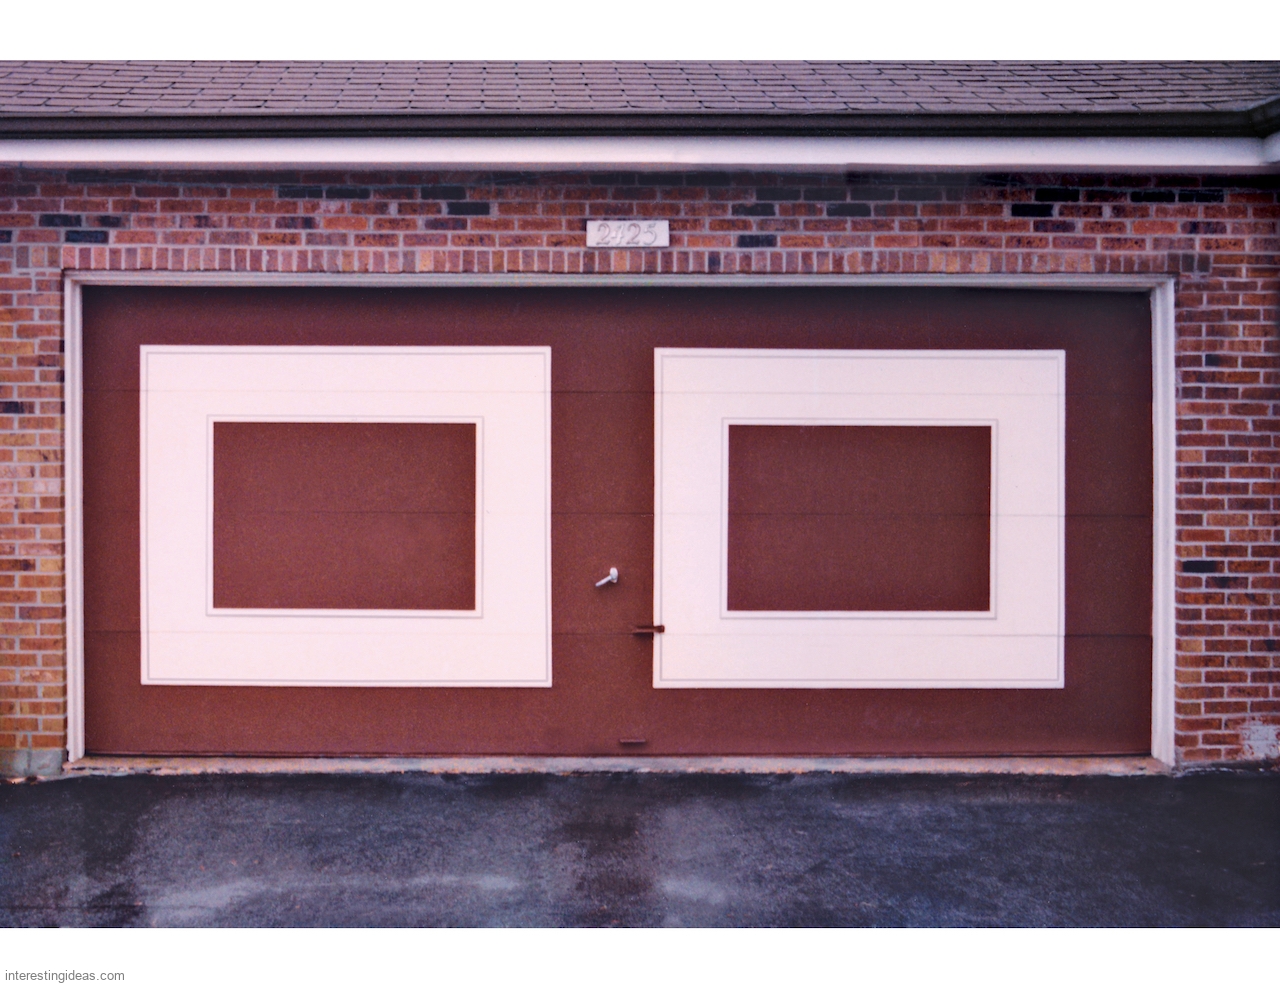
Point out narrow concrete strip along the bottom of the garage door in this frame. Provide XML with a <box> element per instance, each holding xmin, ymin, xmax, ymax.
<box><xmin>37</xmin><ymin>755</ymin><xmax>1174</xmax><ymax>777</ymax></box>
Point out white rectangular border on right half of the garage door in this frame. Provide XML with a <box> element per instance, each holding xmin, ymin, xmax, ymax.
<box><xmin>654</xmin><ymin>348</ymin><xmax>1066</xmax><ymax>689</ymax></box>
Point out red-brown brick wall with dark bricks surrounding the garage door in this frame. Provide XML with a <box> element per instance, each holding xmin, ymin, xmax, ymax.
<box><xmin>0</xmin><ymin>169</ymin><xmax>1280</xmax><ymax>765</ymax></box>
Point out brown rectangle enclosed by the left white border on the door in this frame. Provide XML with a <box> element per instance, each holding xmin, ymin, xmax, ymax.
<box><xmin>214</xmin><ymin>421</ymin><xmax>476</xmax><ymax>610</ymax></box>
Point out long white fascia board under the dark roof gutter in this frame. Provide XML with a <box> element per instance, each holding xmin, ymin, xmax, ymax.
<box><xmin>0</xmin><ymin>134</ymin><xmax>1280</xmax><ymax>173</ymax></box>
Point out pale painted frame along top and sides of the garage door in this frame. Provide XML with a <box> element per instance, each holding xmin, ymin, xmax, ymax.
<box><xmin>63</xmin><ymin>271</ymin><xmax>1176</xmax><ymax>765</ymax></box>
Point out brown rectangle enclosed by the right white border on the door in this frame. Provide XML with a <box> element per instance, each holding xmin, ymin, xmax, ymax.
<box><xmin>728</xmin><ymin>425</ymin><xmax>991</xmax><ymax>610</ymax></box>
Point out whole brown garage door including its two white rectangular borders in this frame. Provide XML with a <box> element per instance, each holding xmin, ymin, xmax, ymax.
<box><xmin>84</xmin><ymin>287</ymin><xmax>1152</xmax><ymax>755</ymax></box>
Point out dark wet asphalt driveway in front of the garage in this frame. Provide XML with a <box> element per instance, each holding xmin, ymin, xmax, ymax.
<box><xmin>0</xmin><ymin>772</ymin><xmax>1280</xmax><ymax>927</ymax></box>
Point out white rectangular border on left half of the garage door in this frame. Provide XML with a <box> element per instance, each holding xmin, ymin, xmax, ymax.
<box><xmin>141</xmin><ymin>346</ymin><xmax>552</xmax><ymax>686</ymax></box>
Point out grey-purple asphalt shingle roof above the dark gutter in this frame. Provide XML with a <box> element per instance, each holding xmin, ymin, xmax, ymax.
<box><xmin>0</xmin><ymin>61</ymin><xmax>1280</xmax><ymax>132</ymax></box>
